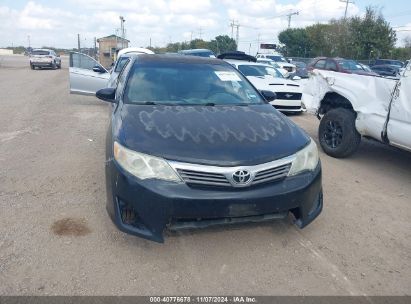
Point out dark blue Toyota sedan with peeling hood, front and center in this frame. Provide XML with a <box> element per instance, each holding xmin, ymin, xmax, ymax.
<box><xmin>69</xmin><ymin>54</ymin><xmax>323</xmax><ymax>242</ymax></box>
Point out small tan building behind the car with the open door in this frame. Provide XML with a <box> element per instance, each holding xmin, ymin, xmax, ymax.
<box><xmin>97</xmin><ymin>35</ymin><xmax>130</xmax><ymax>68</ymax></box>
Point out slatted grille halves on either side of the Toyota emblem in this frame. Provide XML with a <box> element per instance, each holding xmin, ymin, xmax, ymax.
<box><xmin>177</xmin><ymin>162</ymin><xmax>291</xmax><ymax>187</ymax></box>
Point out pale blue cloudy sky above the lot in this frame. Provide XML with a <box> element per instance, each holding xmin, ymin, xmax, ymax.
<box><xmin>0</xmin><ymin>0</ymin><xmax>411</xmax><ymax>54</ymax></box>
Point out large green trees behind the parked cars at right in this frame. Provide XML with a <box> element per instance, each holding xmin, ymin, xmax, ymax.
<box><xmin>278</xmin><ymin>6</ymin><xmax>398</xmax><ymax>59</ymax></box>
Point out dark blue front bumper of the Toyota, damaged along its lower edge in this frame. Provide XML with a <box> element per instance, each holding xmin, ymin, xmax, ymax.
<box><xmin>106</xmin><ymin>160</ymin><xmax>323</xmax><ymax>242</ymax></box>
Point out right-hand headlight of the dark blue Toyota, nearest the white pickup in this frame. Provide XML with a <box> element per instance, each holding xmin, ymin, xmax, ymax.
<box><xmin>288</xmin><ymin>139</ymin><xmax>319</xmax><ymax>175</ymax></box>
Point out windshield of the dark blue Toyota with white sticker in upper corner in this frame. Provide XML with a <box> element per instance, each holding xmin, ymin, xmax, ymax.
<box><xmin>124</xmin><ymin>62</ymin><xmax>265</xmax><ymax>105</ymax></box>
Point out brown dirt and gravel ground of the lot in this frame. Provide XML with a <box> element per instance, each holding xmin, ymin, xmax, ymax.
<box><xmin>0</xmin><ymin>57</ymin><xmax>411</xmax><ymax>295</ymax></box>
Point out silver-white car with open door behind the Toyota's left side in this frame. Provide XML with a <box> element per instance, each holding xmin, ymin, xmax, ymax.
<box><xmin>69</xmin><ymin>48</ymin><xmax>154</xmax><ymax>95</ymax></box>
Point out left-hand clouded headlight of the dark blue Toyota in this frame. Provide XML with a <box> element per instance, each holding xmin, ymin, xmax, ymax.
<box><xmin>114</xmin><ymin>142</ymin><xmax>181</xmax><ymax>182</ymax></box>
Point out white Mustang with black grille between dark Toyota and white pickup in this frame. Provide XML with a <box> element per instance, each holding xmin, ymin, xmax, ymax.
<box><xmin>225</xmin><ymin>59</ymin><xmax>304</xmax><ymax>112</ymax></box>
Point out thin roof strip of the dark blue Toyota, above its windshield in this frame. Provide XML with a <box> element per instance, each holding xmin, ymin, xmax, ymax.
<box><xmin>132</xmin><ymin>54</ymin><xmax>226</xmax><ymax>65</ymax></box>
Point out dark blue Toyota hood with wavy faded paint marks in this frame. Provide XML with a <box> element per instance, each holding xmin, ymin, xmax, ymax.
<box><xmin>113</xmin><ymin>104</ymin><xmax>309</xmax><ymax>166</ymax></box>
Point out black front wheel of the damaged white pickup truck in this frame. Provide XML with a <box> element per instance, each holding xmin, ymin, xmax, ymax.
<box><xmin>318</xmin><ymin>108</ymin><xmax>361</xmax><ymax>158</ymax></box>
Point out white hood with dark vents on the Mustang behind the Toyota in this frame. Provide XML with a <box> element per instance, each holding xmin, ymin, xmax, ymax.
<box><xmin>247</xmin><ymin>76</ymin><xmax>302</xmax><ymax>93</ymax></box>
